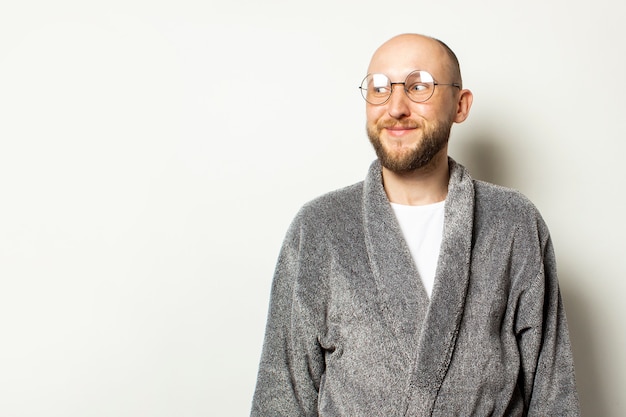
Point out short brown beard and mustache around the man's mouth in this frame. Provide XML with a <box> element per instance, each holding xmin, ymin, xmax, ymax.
<box><xmin>367</xmin><ymin>121</ymin><xmax>452</xmax><ymax>173</ymax></box>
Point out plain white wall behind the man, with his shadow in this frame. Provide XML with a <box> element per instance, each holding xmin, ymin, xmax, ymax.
<box><xmin>0</xmin><ymin>0</ymin><xmax>626</xmax><ymax>417</ymax></box>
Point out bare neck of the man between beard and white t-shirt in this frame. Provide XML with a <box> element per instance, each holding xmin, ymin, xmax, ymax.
<box><xmin>382</xmin><ymin>149</ymin><xmax>450</xmax><ymax>206</ymax></box>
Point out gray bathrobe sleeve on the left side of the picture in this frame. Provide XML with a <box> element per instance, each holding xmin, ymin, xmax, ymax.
<box><xmin>251</xmin><ymin>213</ymin><xmax>324</xmax><ymax>417</ymax></box>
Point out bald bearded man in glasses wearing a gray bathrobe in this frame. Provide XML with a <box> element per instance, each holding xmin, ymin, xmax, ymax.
<box><xmin>247</xmin><ymin>34</ymin><xmax>579</xmax><ymax>417</ymax></box>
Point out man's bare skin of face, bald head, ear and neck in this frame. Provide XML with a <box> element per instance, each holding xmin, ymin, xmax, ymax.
<box><xmin>366</xmin><ymin>34</ymin><xmax>473</xmax><ymax>205</ymax></box>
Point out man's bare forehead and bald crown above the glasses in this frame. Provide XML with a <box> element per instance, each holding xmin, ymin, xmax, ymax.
<box><xmin>367</xmin><ymin>35</ymin><xmax>449</xmax><ymax>80</ymax></box>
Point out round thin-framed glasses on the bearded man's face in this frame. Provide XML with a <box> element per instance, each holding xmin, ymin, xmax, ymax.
<box><xmin>359</xmin><ymin>70</ymin><xmax>461</xmax><ymax>105</ymax></box>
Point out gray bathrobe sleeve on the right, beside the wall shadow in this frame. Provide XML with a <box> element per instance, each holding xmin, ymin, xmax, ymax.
<box><xmin>516</xmin><ymin>232</ymin><xmax>580</xmax><ymax>417</ymax></box>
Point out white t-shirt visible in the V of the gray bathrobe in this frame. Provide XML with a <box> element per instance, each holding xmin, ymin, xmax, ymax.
<box><xmin>391</xmin><ymin>201</ymin><xmax>445</xmax><ymax>297</ymax></box>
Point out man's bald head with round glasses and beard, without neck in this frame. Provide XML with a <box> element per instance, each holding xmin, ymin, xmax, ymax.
<box><xmin>366</xmin><ymin>34</ymin><xmax>472</xmax><ymax>173</ymax></box>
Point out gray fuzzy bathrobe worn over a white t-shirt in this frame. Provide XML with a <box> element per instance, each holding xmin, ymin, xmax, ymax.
<box><xmin>251</xmin><ymin>159</ymin><xmax>579</xmax><ymax>417</ymax></box>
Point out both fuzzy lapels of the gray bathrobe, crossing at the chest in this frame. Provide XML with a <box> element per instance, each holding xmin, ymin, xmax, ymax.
<box><xmin>363</xmin><ymin>159</ymin><xmax>474</xmax><ymax>416</ymax></box>
